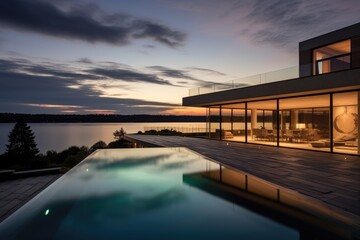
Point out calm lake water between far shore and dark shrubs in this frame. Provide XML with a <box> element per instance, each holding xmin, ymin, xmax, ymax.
<box><xmin>0</xmin><ymin>122</ymin><xmax>206</xmax><ymax>154</ymax></box>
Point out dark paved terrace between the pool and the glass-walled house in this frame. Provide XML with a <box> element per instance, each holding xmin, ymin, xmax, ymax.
<box><xmin>126</xmin><ymin>134</ymin><xmax>360</xmax><ymax>223</ymax></box>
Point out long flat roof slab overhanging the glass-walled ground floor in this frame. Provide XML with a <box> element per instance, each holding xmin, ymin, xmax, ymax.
<box><xmin>183</xmin><ymin>69</ymin><xmax>360</xmax><ymax>107</ymax></box>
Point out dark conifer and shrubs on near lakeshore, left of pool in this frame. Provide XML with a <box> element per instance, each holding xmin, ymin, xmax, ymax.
<box><xmin>0</xmin><ymin>121</ymin><xmax>133</xmax><ymax>171</ymax></box>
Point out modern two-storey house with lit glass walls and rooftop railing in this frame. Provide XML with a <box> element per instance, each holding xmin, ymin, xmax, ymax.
<box><xmin>183</xmin><ymin>23</ymin><xmax>360</xmax><ymax>155</ymax></box>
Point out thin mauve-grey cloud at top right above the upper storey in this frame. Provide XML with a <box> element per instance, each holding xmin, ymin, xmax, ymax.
<box><xmin>167</xmin><ymin>0</ymin><xmax>360</xmax><ymax>49</ymax></box>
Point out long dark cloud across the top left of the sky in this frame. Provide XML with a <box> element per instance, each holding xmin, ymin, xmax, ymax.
<box><xmin>0</xmin><ymin>0</ymin><xmax>186</xmax><ymax>47</ymax></box>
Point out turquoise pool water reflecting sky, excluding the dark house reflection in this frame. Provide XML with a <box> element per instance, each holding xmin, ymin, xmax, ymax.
<box><xmin>0</xmin><ymin>148</ymin><xmax>352</xmax><ymax>239</ymax></box>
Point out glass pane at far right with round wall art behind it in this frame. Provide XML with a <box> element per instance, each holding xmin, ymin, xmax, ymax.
<box><xmin>332</xmin><ymin>92</ymin><xmax>360</xmax><ymax>154</ymax></box>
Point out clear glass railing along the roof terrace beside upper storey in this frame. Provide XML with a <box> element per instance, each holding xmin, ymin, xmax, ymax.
<box><xmin>189</xmin><ymin>66</ymin><xmax>299</xmax><ymax>96</ymax></box>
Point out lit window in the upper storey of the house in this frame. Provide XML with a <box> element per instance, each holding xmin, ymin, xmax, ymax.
<box><xmin>313</xmin><ymin>39</ymin><xmax>351</xmax><ymax>75</ymax></box>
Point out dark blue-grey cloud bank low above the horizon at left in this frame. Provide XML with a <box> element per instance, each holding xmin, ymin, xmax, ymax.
<box><xmin>0</xmin><ymin>59</ymin><xmax>179</xmax><ymax>114</ymax></box>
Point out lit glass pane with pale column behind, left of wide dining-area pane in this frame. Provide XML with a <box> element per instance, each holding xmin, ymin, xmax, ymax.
<box><xmin>247</xmin><ymin>100</ymin><xmax>277</xmax><ymax>145</ymax></box>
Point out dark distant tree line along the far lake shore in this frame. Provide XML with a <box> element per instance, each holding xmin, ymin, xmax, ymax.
<box><xmin>0</xmin><ymin>113</ymin><xmax>206</xmax><ymax>123</ymax></box>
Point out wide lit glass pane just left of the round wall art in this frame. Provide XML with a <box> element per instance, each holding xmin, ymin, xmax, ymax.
<box><xmin>279</xmin><ymin>94</ymin><xmax>330</xmax><ymax>151</ymax></box>
